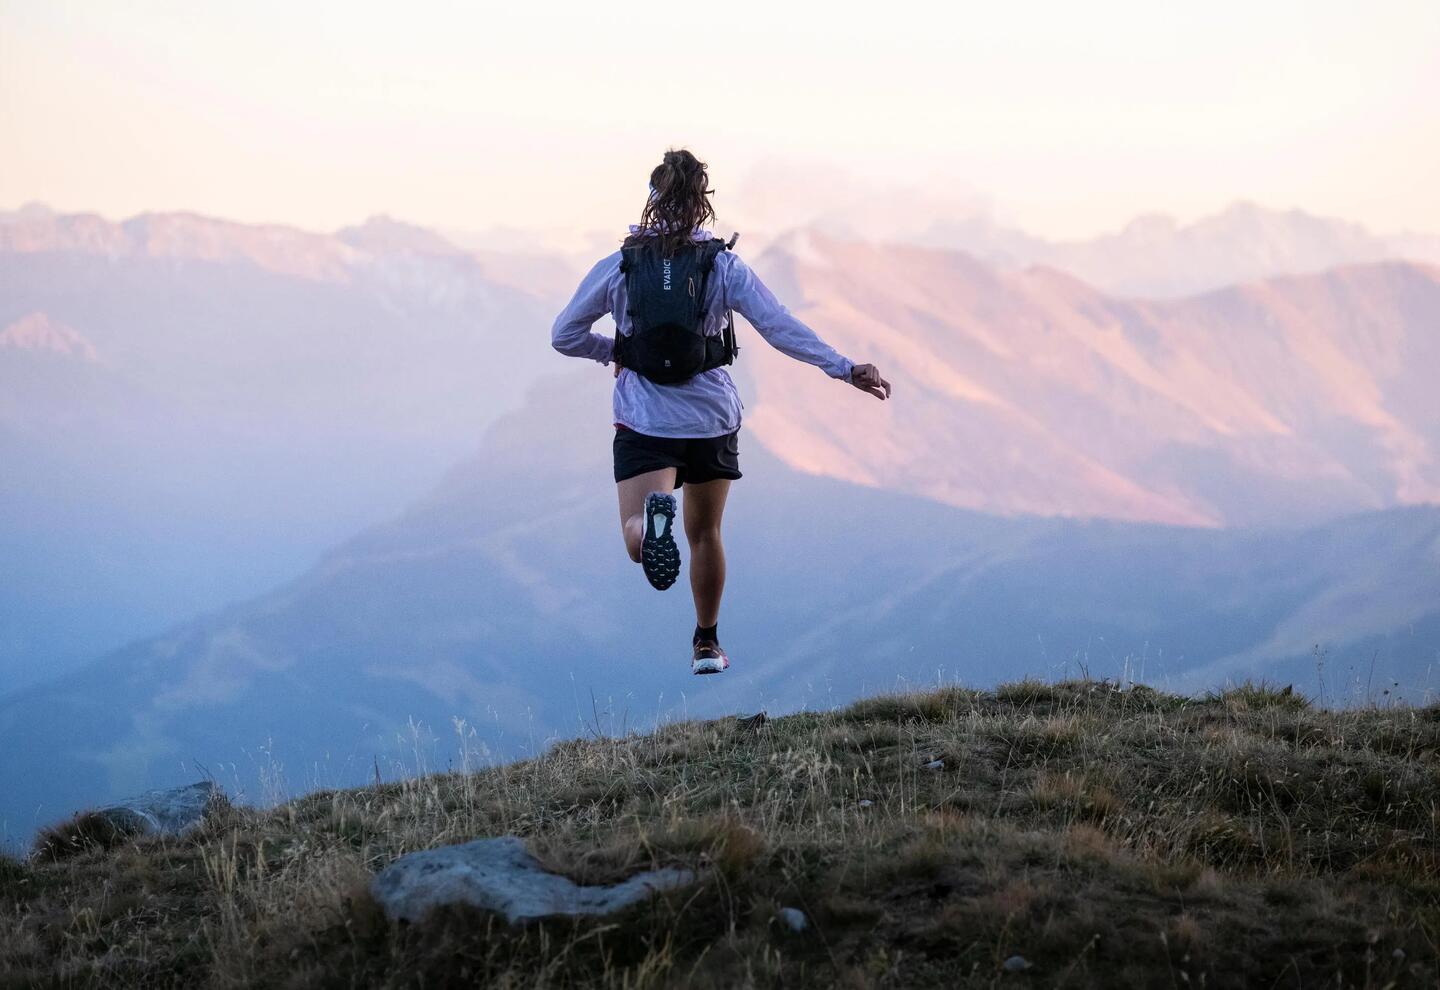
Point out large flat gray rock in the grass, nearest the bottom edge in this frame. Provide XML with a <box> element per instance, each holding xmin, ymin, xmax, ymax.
<box><xmin>370</xmin><ymin>836</ymin><xmax>696</xmax><ymax>924</ymax></box>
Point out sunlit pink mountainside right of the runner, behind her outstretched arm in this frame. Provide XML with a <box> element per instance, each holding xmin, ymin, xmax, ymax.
<box><xmin>737</xmin><ymin>232</ymin><xmax>1440</xmax><ymax>525</ymax></box>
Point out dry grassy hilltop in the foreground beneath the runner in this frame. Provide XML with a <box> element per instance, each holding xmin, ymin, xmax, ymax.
<box><xmin>0</xmin><ymin>681</ymin><xmax>1440</xmax><ymax>987</ymax></box>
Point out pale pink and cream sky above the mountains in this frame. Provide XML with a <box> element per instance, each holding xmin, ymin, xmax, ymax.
<box><xmin>0</xmin><ymin>0</ymin><xmax>1440</xmax><ymax>236</ymax></box>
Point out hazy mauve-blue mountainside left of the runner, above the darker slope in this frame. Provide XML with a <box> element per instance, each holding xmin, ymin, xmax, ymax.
<box><xmin>0</xmin><ymin>209</ymin><xmax>554</xmax><ymax>684</ymax></box>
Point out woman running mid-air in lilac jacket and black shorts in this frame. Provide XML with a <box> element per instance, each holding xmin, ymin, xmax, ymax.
<box><xmin>550</xmin><ymin>150</ymin><xmax>890</xmax><ymax>673</ymax></box>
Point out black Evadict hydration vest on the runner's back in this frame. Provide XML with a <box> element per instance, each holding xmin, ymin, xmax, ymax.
<box><xmin>615</xmin><ymin>237</ymin><xmax>740</xmax><ymax>386</ymax></box>
